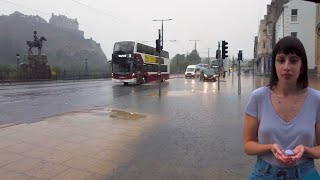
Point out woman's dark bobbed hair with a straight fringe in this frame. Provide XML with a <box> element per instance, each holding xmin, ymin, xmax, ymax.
<box><xmin>269</xmin><ymin>36</ymin><xmax>309</xmax><ymax>89</ymax></box>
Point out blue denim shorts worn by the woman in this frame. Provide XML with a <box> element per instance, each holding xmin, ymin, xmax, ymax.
<box><xmin>248</xmin><ymin>158</ymin><xmax>320</xmax><ymax>180</ymax></box>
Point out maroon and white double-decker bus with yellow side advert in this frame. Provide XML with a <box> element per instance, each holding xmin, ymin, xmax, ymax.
<box><xmin>111</xmin><ymin>41</ymin><xmax>170</xmax><ymax>84</ymax></box>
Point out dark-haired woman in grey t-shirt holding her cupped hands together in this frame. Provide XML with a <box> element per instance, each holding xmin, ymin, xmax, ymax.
<box><xmin>244</xmin><ymin>36</ymin><xmax>320</xmax><ymax>180</ymax></box>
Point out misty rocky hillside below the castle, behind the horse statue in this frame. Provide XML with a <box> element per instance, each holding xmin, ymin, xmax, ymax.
<box><xmin>0</xmin><ymin>12</ymin><xmax>108</xmax><ymax>72</ymax></box>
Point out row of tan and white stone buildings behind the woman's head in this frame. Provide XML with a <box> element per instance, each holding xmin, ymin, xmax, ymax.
<box><xmin>254</xmin><ymin>0</ymin><xmax>320</xmax><ymax>74</ymax></box>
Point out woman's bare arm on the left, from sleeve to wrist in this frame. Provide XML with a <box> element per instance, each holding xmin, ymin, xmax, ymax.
<box><xmin>243</xmin><ymin>114</ymin><xmax>272</xmax><ymax>155</ymax></box>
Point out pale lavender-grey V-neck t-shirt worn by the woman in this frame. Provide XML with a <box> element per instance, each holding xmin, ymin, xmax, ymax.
<box><xmin>245</xmin><ymin>87</ymin><xmax>320</xmax><ymax>166</ymax></box>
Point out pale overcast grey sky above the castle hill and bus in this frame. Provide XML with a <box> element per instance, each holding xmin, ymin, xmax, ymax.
<box><xmin>0</xmin><ymin>0</ymin><xmax>271</xmax><ymax>59</ymax></box>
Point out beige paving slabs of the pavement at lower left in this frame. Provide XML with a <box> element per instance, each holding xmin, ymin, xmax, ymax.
<box><xmin>0</xmin><ymin>108</ymin><xmax>157</xmax><ymax>180</ymax></box>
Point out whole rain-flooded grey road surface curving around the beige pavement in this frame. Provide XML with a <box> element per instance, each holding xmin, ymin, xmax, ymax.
<box><xmin>0</xmin><ymin>75</ymin><xmax>319</xmax><ymax>179</ymax></box>
